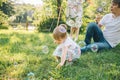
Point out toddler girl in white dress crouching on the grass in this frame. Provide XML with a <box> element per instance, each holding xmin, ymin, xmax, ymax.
<box><xmin>53</xmin><ymin>24</ymin><xmax>81</xmax><ymax>68</ymax></box>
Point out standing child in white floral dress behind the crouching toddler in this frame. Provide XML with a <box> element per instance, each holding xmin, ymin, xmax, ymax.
<box><xmin>66</xmin><ymin>0</ymin><xmax>82</xmax><ymax>41</ymax></box>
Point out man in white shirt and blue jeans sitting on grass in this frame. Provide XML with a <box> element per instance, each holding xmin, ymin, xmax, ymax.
<box><xmin>81</xmin><ymin>0</ymin><xmax>120</xmax><ymax>53</ymax></box>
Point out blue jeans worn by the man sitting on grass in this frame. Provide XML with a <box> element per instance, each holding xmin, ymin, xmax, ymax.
<box><xmin>81</xmin><ymin>22</ymin><xmax>112</xmax><ymax>53</ymax></box>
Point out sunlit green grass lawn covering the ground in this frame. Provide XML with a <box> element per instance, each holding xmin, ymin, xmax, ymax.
<box><xmin>0</xmin><ymin>30</ymin><xmax>120</xmax><ymax>80</ymax></box>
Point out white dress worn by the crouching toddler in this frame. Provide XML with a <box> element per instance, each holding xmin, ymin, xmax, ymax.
<box><xmin>53</xmin><ymin>37</ymin><xmax>81</xmax><ymax>60</ymax></box>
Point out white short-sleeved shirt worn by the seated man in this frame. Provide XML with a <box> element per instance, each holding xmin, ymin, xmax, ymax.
<box><xmin>99</xmin><ymin>13</ymin><xmax>120</xmax><ymax>47</ymax></box>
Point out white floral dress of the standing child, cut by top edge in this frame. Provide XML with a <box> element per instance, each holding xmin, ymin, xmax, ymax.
<box><xmin>66</xmin><ymin>0</ymin><xmax>83</xmax><ymax>27</ymax></box>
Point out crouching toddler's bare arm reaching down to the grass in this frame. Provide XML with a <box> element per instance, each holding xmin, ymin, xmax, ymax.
<box><xmin>57</xmin><ymin>46</ymin><xmax>68</xmax><ymax>68</ymax></box>
